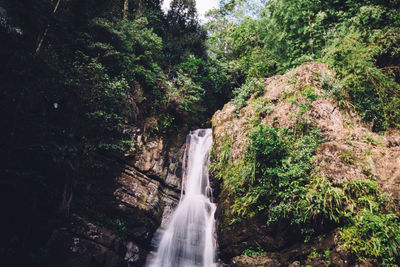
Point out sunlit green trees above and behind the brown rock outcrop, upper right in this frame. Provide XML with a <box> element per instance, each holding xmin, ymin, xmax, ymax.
<box><xmin>208</xmin><ymin>0</ymin><xmax>400</xmax><ymax>131</ymax></box>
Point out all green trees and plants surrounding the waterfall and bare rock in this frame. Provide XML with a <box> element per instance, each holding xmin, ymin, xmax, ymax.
<box><xmin>0</xmin><ymin>0</ymin><xmax>400</xmax><ymax>266</ymax></box>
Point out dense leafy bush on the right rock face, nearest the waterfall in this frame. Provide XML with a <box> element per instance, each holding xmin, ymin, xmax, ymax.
<box><xmin>212</xmin><ymin>122</ymin><xmax>320</xmax><ymax>233</ymax></box>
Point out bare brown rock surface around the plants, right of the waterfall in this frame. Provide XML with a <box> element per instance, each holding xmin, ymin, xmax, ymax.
<box><xmin>212</xmin><ymin>63</ymin><xmax>400</xmax><ymax>266</ymax></box>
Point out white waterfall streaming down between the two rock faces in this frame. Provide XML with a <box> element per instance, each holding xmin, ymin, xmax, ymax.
<box><xmin>148</xmin><ymin>129</ymin><xmax>216</xmax><ymax>267</ymax></box>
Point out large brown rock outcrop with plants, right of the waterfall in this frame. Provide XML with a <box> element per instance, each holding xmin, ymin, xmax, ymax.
<box><xmin>212</xmin><ymin>62</ymin><xmax>400</xmax><ymax>266</ymax></box>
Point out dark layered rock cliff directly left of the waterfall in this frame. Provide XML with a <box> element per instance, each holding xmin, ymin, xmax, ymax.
<box><xmin>48</xmin><ymin>127</ymin><xmax>186</xmax><ymax>267</ymax></box>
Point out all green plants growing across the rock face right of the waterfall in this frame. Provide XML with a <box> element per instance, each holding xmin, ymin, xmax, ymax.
<box><xmin>211</xmin><ymin>122</ymin><xmax>400</xmax><ymax>266</ymax></box>
